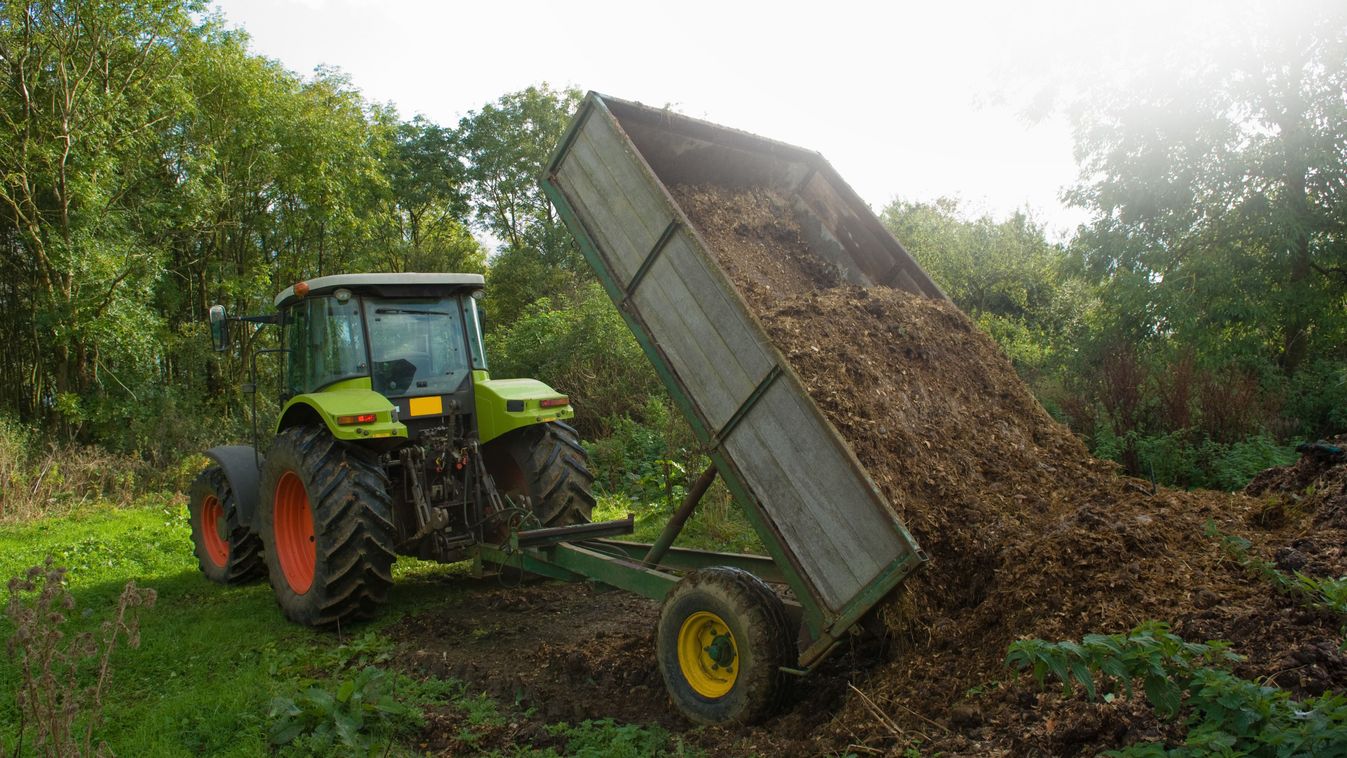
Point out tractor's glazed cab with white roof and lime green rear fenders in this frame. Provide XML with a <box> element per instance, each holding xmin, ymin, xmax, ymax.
<box><xmin>276</xmin><ymin>273</ymin><xmax>575</xmax><ymax>444</ymax></box>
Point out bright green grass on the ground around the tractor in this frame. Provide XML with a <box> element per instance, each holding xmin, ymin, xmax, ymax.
<box><xmin>0</xmin><ymin>495</ymin><xmax>705</xmax><ymax>755</ymax></box>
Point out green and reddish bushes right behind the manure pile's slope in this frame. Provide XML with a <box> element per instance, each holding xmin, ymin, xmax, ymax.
<box><xmin>882</xmin><ymin>199</ymin><xmax>1309</xmax><ymax>490</ymax></box>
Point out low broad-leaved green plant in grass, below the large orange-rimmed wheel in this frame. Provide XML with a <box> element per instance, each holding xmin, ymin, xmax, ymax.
<box><xmin>268</xmin><ymin>666</ymin><xmax>419</xmax><ymax>754</ymax></box>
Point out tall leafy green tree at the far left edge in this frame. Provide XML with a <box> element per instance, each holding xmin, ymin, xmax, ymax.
<box><xmin>0</xmin><ymin>0</ymin><xmax>201</xmax><ymax>428</ymax></box>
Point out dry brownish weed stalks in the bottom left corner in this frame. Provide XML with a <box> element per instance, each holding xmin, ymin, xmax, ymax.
<box><xmin>5</xmin><ymin>557</ymin><xmax>156</xmax><ymax>755</ymax></box>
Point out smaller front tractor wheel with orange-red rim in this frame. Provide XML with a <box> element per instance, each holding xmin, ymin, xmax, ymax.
<box><xmin>187</xmin><ymin>466</ymin><xmax>267</xmax><ymax>584</ymax></box>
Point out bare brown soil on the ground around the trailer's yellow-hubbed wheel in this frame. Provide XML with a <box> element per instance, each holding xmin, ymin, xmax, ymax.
<box><xmin>387</xmin><ymin>579</ymin><xmax>884</xmax><ymax>755</ymax></box>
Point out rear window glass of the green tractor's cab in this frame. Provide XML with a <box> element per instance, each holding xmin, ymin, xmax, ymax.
<box><xmin>365</xmin><ymin>298</ymin><xmax>469</xmax><ymax>397</ymax></box>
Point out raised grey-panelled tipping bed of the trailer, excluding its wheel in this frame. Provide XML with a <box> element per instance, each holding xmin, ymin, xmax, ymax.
<box><xmin>519</xmin><ymin>93</ymin><xmax>944</xmax><ymax>699</ymax></box>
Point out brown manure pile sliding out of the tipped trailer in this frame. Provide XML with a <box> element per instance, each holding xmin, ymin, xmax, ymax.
<box><xmin>674</xmin><ymin>186</ymin><xmax>1347</xmax><ymax>755</ymax></box>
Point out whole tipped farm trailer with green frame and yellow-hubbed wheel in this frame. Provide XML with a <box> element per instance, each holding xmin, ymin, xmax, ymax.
<box><xmin>480</xmin><ymin>93</ymin><xmax>944</xmax><ymax>723</ymax></box>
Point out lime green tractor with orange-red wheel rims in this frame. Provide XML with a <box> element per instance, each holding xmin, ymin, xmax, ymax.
<box><xmin>190</xmin><ymin>273</ymin><xmax>594</xmax><ymax>627</ymax></box>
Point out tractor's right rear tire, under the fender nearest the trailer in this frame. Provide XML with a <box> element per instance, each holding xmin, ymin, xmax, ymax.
<box><xmin>486</xmin><ymin>421</ymin><xmax>594</xmax><ymax>528</ymax></box>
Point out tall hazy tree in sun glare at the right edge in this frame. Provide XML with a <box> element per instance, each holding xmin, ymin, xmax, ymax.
<box><xmin>1068</xmin><ymin>5</ymin><xmax>1347</xmax><ymax>374</ymax></box>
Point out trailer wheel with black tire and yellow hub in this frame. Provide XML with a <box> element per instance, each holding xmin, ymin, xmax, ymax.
<box><xmin>655</xmin><ymin>567</ymin><xmax>797</xmax><ymax>724</ymax></box>
